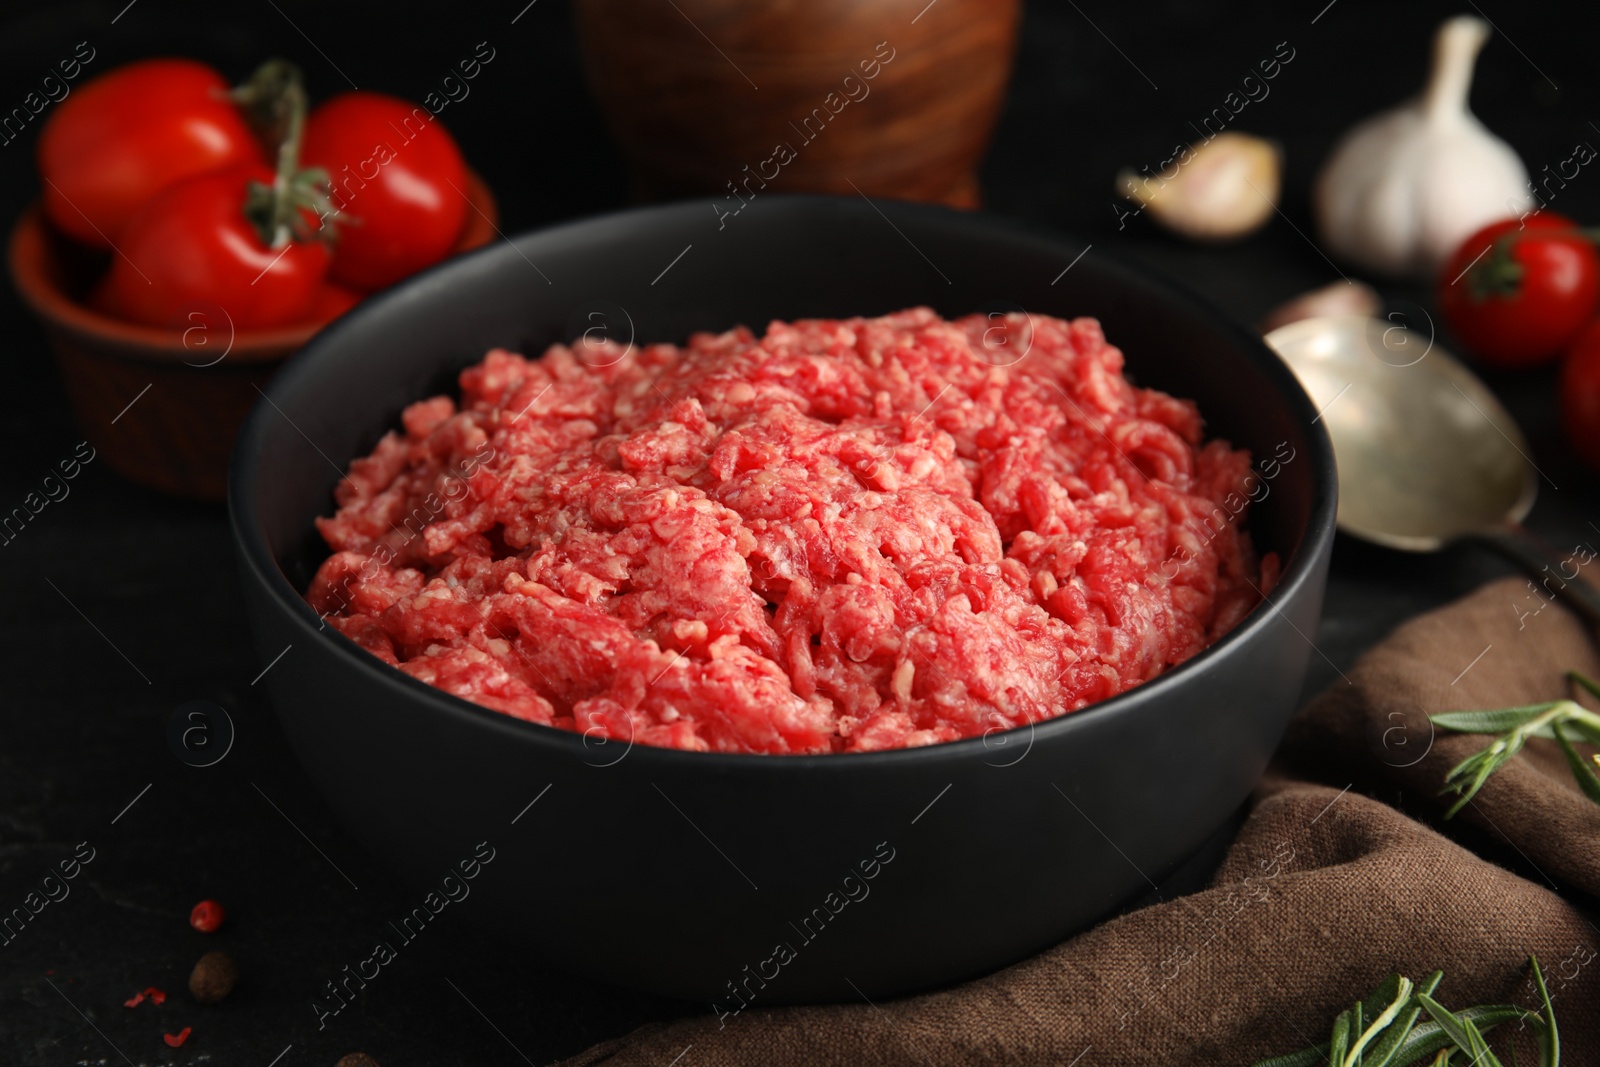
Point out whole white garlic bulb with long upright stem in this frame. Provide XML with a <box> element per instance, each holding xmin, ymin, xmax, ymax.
<box><xmin>1314</xmin><ymin>16</ymin><xmax>1528</xmax><ymax>277</ymax></box>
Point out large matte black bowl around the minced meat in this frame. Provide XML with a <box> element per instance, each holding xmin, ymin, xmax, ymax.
<box><xmin>229</xmin><ymin>197</ymin><xmax>1334</xmax><ymax>1011</ymax></box>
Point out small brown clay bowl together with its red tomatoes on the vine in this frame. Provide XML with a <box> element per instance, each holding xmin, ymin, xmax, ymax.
<box><xmin>10</xmin><ymin>59</ymin><xmax>498</xmax><ymax>501</ymax></box>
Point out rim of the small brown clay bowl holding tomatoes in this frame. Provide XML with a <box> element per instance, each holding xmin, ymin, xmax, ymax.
<box><xmin>6</xmin><ymin>166</ymin><xmax>499</xmax><ymax>366</ymax></box>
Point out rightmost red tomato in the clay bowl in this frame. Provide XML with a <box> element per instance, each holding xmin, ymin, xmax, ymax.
<box><xmin>301</xmin><ymin>93</ymin><xmax>467</xmax><ymax>291</ymax></box>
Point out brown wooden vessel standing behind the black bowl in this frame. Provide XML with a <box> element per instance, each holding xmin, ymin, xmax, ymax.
<box><xmin>576</xmin><ymin>0</ymin><xmax>1021</xmax><ymax>209</ymax></box>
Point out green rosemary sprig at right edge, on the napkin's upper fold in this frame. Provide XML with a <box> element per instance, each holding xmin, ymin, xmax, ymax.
<box><xmin>1429</xmin><ymin>670</ymin><xmax>1600</xmax><ymax>819</ymax></box>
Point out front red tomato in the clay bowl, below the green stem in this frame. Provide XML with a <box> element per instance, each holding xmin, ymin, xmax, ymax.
<box><xmin>96</xmin><ymin>166</ymin><xmax>330</xmax><ymax>330</ymax></box>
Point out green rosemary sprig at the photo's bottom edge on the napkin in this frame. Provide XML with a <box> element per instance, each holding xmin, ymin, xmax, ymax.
<box><xmin>1251</xmin><ymin>955</ymin><xmax>1562</xmax><ymax>1067</ymax></box>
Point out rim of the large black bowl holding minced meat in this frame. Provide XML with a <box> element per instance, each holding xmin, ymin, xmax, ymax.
<box><xmin>227</xmin><ymin>194</ymin><xmax>1338</xmax><ymax>774</ymax></box>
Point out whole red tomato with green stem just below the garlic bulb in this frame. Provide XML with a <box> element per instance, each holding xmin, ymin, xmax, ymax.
<box><xmin>1438</xmin><ymin>211</ymin><xmax>1600</xmax><ymax>366</ymax></box>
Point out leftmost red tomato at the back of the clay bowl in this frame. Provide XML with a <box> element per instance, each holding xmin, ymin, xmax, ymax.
<box><xmin>38</xmin><ymin>59</ymin><xmax>264</xmax><ymax>248</ymax></box>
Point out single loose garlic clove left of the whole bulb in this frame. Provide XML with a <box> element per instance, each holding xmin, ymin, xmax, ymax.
<box><xmin>1117</xmin><ymin>131</ymin><xmax>1282</xmax><ymax>240</ymax></box>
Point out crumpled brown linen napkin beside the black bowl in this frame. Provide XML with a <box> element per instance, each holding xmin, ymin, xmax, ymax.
<box><xmin>566</xmin><ymin>581</ymin><xmax>1600</xmax><ymax>1067</ymax></box>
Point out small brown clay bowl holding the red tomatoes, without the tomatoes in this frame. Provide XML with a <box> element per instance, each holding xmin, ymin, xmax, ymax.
<box><xmin>10</xmin><ymin>171</ymin><xmax>498</xmax><ymax>501</ymax></box>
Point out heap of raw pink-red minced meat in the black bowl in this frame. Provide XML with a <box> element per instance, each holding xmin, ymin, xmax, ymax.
<box><xmin>307</xmin><ymin>309</ymin><xmax>1277</xmax><ymax>753</ymax></box>
